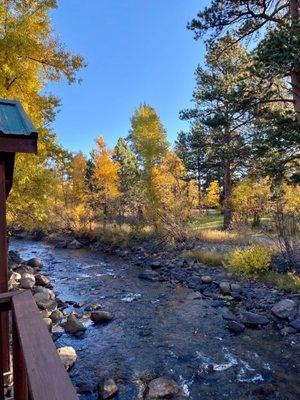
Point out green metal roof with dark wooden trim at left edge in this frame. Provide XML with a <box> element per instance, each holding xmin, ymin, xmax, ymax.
<box><xmin>0</xmin><ymin>99</ymin><xmax>37</xmax><ymax>136</ymax></box>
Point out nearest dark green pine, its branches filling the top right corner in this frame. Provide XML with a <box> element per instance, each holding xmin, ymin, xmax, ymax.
<box><xmin>188</xmin><ymin>0</ymin><xmax>300</xmax><ymax>122</ymax></box>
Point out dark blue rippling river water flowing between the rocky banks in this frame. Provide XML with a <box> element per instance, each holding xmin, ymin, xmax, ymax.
<box><xmin>10</xmin><ymin>241</ymin><xmax>300</xmax><ymax>400</ymax></box>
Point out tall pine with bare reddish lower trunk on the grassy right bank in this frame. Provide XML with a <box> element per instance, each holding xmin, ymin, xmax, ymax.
<box><xmin>181</xmin><ymin>36</ymin><xmax>253</xmax><ymax>229</ymax></box>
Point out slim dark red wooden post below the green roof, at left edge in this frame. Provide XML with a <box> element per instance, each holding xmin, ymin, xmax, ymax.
<box><xmin>0</xmin><ymin>158</ymin><xmax>9</xmax><ymax>372</ymax></box>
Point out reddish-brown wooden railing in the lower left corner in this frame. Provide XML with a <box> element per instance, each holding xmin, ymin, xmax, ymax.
<box><xmin>0</xmin><ymin>291</ymin><xmax>78</xmax><ymax>400</ymax></box>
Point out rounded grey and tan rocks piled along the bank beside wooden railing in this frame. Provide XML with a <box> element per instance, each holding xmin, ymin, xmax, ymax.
<box><xmin>8</xmin><ymin>248</ymin><xmax>118</xmax><ymax>400</ymax></box>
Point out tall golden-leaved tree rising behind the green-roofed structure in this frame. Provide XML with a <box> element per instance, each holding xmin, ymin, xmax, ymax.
<box><xmin>0</xmin><ymin>0</ymin><xmax>84</xmax><ymax>229</ymax></box>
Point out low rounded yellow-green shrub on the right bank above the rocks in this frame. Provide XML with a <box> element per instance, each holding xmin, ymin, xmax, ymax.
<box><xmin>225</xmin><ymin>245</ymin><xmax>271</xmax><ymax>275</ymax></box>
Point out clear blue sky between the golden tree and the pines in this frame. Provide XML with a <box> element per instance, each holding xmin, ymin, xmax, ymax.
<box><xmin>47</xmin><ymin>0</ymin><xmax>208</xmax><ymax>154</ymax></box>
